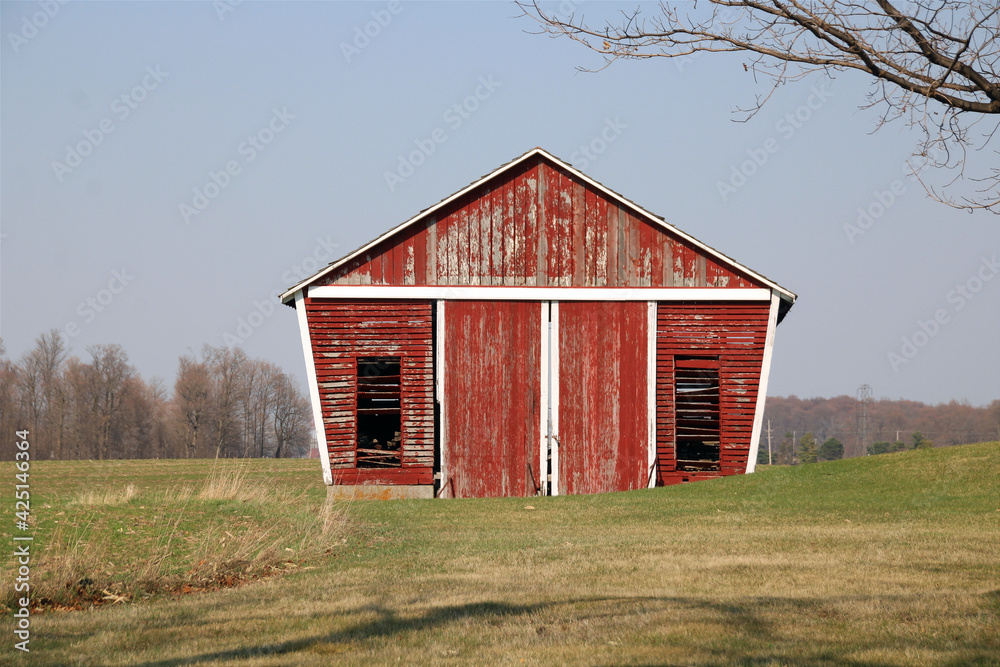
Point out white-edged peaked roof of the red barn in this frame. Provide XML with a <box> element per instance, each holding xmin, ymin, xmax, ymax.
<box><xmin>281</xmin><ymin>148</ymin><xmax>796</xmax><ymax>319</ymax></box>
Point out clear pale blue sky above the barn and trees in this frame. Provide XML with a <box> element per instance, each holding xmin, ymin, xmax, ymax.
<box><xmin>0</xmin><ymin>1</ymin><xmax>1000</xmax><ymax>404</ymax></box>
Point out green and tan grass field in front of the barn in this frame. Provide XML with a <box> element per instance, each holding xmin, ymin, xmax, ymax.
<box><xmin>0</xmin><ymin>443</ymin><xmax>1000</xmax><ymax>667</ymax></box>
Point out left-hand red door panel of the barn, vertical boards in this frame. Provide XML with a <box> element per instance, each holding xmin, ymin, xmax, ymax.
<box><xmin>442</xmin><ymin>301</ymin><xmax>542</xmax><ymax>498</ymax></box>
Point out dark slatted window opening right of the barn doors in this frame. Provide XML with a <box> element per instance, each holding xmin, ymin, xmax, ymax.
<box><xmin>674</xmin><ymin>357</ymin><xmax>721</xmax><ymax>471</ymax></box>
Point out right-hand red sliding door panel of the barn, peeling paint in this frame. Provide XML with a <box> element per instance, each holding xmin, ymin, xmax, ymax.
<box><xmin>557</xmin><ymin>301</ymin><xmax>650</xmax><ymax>494</ymax></box>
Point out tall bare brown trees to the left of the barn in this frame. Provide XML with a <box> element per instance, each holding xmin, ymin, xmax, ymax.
<box><xmin>0</xmin><ymin>330</ymin><xmax>315</xmax><ymax>459</ymax></box>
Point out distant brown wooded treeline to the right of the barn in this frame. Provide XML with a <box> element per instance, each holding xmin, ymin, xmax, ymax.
<box><xmin>758</xmin><ymin>396</ymin><xmax>1000</xmax><ymax>457</ymax></box>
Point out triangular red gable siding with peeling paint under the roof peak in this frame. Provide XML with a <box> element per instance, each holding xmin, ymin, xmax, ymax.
<box><xmin>316</xmin><ymin>157</ymin><xmax>764</xmax><ymax>287</ymax></box>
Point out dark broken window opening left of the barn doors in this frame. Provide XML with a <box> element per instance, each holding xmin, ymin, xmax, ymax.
<box><xmin>356</xmin><ymin>357</ymin><xmax>403</xmax><ymax>468</ymax></box>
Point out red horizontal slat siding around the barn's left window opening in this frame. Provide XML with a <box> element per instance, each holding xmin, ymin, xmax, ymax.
<box><xmin>305</xmin><ymin>298</ymin><xmax>434</xmax><ymax>484</ymax></box>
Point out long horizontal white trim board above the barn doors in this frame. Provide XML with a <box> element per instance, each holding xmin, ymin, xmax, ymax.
<box><xmin>300</xmin><ymin>285</ymin><xmax>773</xmax><ymax>301</ymax></box>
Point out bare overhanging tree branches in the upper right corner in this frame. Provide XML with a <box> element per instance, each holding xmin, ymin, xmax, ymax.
<box><xmin>518</xmin><ymin>0</ymin><xmax>1000</xmax><ymax>214</ymax></box>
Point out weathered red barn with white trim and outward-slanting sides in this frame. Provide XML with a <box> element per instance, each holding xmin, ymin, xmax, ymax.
<box><xmin>282</xmin><ymin>148</ymin><xmax>796</xmax><ymax>498</ymax></box>
